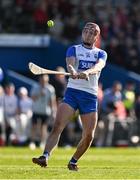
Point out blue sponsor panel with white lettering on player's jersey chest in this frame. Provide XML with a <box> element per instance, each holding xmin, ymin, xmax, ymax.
<box><xmin>78</xmin><ymin>60</ymin><xmax>96</xmax><ymax>70</ymax></box>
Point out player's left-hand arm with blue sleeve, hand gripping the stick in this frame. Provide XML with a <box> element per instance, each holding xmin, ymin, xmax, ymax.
<box><xmin>66</xmin><ymin>46</ymin><xmax>78</xmax><ymax>79</ymax></box>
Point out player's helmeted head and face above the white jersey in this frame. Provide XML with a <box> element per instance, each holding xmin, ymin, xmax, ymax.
<box><xmin>82</xmin><ymin>24</ymin><xmax>99</xmax><ymax>46</ymax></box>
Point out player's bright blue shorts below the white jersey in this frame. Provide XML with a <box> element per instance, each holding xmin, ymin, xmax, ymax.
<box><xmin>63</xmin><ymin>88</ymin><xmax>98</xmax><ymax>114</ymax></box>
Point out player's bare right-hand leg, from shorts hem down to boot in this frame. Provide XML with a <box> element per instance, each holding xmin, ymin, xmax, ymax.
<box><xmin>68</xmin><ymin>112</ymin><xmax>97</xmax><ymax>170</ymax></box>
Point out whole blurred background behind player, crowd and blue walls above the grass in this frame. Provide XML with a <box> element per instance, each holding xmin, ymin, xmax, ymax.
<box><xmin>0</xmin><ymin>0</ymin><xmax>140</xmax><ymax>149</ymax></box>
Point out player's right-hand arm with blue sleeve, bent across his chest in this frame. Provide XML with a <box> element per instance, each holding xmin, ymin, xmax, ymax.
<box><xmin>79</xmin><ymin>51</ymin><xmax>107</xmax><ymax>79</ymax></box>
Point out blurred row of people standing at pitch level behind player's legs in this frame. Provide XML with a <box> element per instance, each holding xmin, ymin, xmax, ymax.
<box><xmin>0</xmin><ymin>67</ymin><xmax>140</xmax><ymax>149</ymax></box>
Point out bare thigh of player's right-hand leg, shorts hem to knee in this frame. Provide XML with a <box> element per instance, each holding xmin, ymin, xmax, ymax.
<box><xmin>81</xmin><ymin>112</ymin><xmax>98</xmax><ymax>135</ymax></box>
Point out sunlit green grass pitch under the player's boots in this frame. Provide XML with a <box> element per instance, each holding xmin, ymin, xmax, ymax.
<box><xmin>0</xmin><ymin>147</ymin><xmax>140</xmax><ymax>179</ymax></box>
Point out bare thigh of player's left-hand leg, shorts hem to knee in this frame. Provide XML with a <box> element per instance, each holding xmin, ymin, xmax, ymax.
<box><xmin>54</xmin><ymin>103</ymin><xmax>75</xmax><ymax>129</ymax></box>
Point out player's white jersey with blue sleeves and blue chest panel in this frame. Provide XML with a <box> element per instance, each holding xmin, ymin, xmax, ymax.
<box><xmin>66</xmin><ymin>44</ymin><xmax>107</xmax><ymax>96</ymax></box>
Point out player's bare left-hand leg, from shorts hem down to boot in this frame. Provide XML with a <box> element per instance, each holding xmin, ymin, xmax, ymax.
<box><xmin>32</xmin><ymin>103</ymin><xmax>75</xmax><ymax>167</ymax></box>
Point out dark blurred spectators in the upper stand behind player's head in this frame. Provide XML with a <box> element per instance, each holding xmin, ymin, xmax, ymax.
<box><xmin>0</xmin><ymin>0</ymin><xmax>140</xmax><ymax>73</ymax></box>
